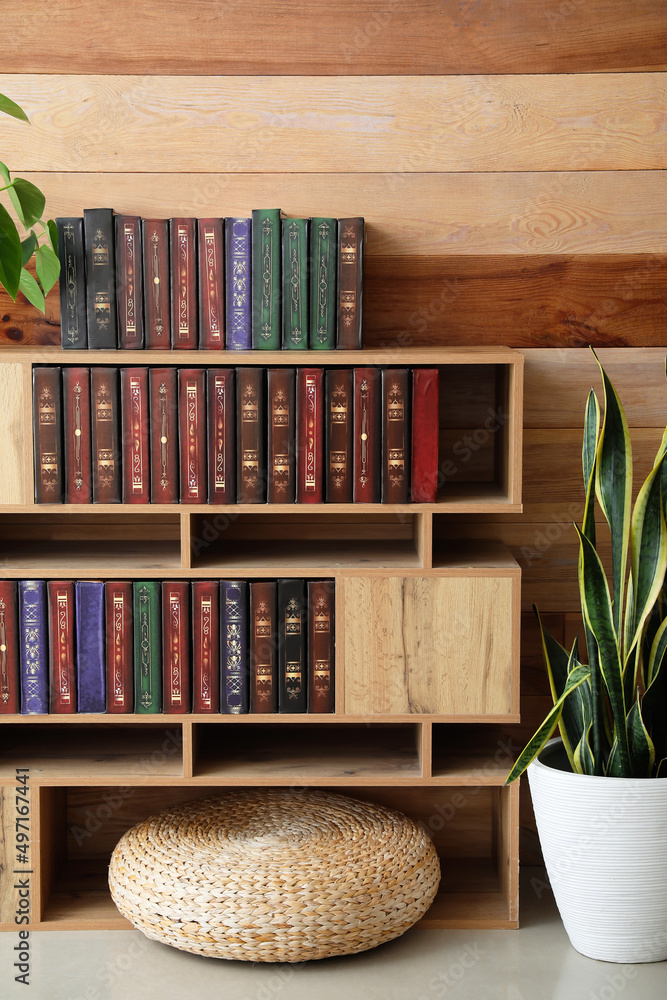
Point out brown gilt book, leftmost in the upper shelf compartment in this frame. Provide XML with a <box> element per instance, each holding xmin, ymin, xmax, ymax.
<box><xmin>32</xmin><ymin>367</ymin><xmax>63</xmax><ymax>503</ymax></box>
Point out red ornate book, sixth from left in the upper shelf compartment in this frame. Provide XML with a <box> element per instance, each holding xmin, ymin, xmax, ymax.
<box><xmin>178</xmin><ymin>368</ymin><xmax>207</xmax><ymax>503</ymax></box>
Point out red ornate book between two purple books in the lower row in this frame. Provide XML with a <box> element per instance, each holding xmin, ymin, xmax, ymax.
<box><xmin>46</xmin><ymin>580</ymin><xmax>76</xmax><ymax>715</ymax></box>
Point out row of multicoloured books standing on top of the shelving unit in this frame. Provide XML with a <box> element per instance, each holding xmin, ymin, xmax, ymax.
<box><xmin>56</xmin><ymin>208</ymin><xmax>364</xmax><ymax>351</ymax></box>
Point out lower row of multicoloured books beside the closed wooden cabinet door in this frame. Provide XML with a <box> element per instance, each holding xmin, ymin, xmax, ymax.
<box><xmin>0</xmin><ymin>579</ymin><xmax>334</xmax><ymax>715</ymax></box>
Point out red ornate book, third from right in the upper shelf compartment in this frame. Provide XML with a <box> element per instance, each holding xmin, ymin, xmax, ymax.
<box><xmin>352</xmin><ymin>368</ymin><xmax>382</xmax><ymax>503</ymax></box>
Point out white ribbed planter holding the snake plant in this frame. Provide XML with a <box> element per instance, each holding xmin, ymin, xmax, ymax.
<box><xmin>528</xmin><ymin>740</ymin><xmax>667</xmax><ymax>963</ymax></box>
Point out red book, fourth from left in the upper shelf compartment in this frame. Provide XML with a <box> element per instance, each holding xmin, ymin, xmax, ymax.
<box><xmin>120</xmin><ymin>368</ymin><xmax>151</xmax><ymax>503</ymax></box>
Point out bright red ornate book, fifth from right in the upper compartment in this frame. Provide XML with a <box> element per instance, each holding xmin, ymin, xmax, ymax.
<box><xmin>296</xmin><ymin>368</ymin><xmax>324</xmax><ymax>503</ymax></box>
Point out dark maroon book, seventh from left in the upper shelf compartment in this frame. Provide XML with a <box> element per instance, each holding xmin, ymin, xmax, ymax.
<box><xmin>206</xmin><ymin>368</ymin><xmax>236</xmax><ymax>503</ymax></box>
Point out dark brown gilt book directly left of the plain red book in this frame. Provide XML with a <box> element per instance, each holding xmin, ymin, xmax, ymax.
<box><xmin>382</xmin><ymin>368</ymin><xmax>410</xmax><ymax>503</ymax></box>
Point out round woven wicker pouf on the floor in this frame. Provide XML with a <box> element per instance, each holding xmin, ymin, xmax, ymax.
<box><xmin>109</xmin><ymin>789</ymin><xmax>440</xmax><ymax>962</ymax></box>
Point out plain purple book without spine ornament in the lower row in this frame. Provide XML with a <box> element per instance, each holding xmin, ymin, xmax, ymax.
<box><xmin>74</xmin><ymin>580</ymin><xmax>106</xmax><ymax>712</ymax></box>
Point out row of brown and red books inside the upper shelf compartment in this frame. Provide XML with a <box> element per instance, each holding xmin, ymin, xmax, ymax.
<box><xmin>33</xmin><ymin>366</ymin><xmax>439</xmax><ymax>504</ymax></box>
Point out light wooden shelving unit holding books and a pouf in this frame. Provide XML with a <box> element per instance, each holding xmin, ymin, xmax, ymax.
<box><xmin>0</xmin><ymin>348</ymin><xmax>523</xmax><ymax>930</ymax></box>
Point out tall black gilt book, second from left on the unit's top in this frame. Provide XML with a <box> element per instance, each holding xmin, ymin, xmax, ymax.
<box><xmin>83</xmin><ymin>208</ymin><xmax>118</xmax><ymax>351</ymax></box>
